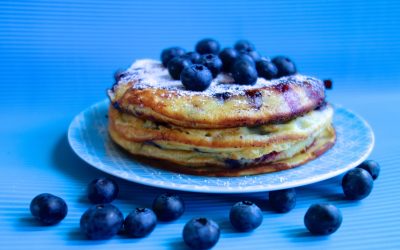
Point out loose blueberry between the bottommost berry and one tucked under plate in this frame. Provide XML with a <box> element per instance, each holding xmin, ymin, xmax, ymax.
<box><xmin>229</xmin><ymin>201</ymin><xmax>263</xmax><ymax>232</ymax></box>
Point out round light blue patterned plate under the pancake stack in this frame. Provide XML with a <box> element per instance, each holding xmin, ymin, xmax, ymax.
<box><xmin>68</xmin><ymin>100</ymin><xmax>374</xmax><ymax>193</ymax></box>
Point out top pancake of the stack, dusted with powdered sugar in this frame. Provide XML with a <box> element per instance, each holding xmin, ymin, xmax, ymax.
<box><xmin>108</xmin><ymin>59</ymin><xmax>325</xmax><ymax>128</ymax></box>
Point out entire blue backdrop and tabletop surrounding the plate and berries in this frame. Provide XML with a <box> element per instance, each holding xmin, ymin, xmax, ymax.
<box><xmin>0</xmin><ymin>0</ymin><xmax>400</xmax><ymax>249</ymax></box>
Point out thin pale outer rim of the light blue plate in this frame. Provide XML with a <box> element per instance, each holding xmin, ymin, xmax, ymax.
<box><xmin>67</xmin><ymin>99</ymin><xmax>375</xmax><ymax>194</ymax></box>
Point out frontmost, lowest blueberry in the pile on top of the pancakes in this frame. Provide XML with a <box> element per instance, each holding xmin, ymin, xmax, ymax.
<box><xmin>181</xmin><ymin>64</ymin><xmax>212</xmax><ymax>91</ymax></box>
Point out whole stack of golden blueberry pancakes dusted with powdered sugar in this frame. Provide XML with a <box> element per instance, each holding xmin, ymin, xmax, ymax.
<box><xmin>108</xmin><ymin>59</ymin><xmax>335</xmax><ymax>176</ymax></box>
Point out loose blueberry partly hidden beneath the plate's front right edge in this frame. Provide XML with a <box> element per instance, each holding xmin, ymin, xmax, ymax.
<box><xmin>269</xmin><ymin>188</ymin><xmax>296</xmax><ymax>213</ymax></box>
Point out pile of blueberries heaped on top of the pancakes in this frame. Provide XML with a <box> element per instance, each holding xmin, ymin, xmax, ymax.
<box><xmin>161</xmin><ymin>38</ymin><xmax>297</xmax><ymax>91</ymax></box>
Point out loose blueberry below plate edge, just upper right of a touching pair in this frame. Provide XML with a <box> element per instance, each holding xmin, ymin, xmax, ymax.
<box><xmin>153</xmin><ymin>193</ymin><xmax>185</xmax><ymax>221</ymax></box>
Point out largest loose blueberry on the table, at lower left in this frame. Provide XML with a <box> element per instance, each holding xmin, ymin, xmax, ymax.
<box><xmin>80</xmin><ymin>204</ymin><xmax>124</xmax><ymax>240</ymax></box>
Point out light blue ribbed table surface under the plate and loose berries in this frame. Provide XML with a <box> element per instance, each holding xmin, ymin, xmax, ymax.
<box><xmin>0</xmin><ymin>88</ymin><xmax>400</xmax><ymax>249</ymax></box>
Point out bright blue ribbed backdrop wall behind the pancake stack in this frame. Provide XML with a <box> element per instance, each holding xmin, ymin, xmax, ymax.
<box><xmin>0</xmin><ymin>0</ymin><xmax>400</xmax><ymax>110</ymax></box>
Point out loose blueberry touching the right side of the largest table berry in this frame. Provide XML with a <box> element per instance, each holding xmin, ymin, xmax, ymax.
<box><xmin>124</xmin><ymin>208</ymin><xmax>157</xmax><ymax>238</ymax></box>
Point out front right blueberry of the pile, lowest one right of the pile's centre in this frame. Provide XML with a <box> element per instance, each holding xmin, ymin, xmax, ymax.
<box><xmin>232</xmin><ymin>60</ymin><xmax>258</xmax><ymax>84</ymax></box>
